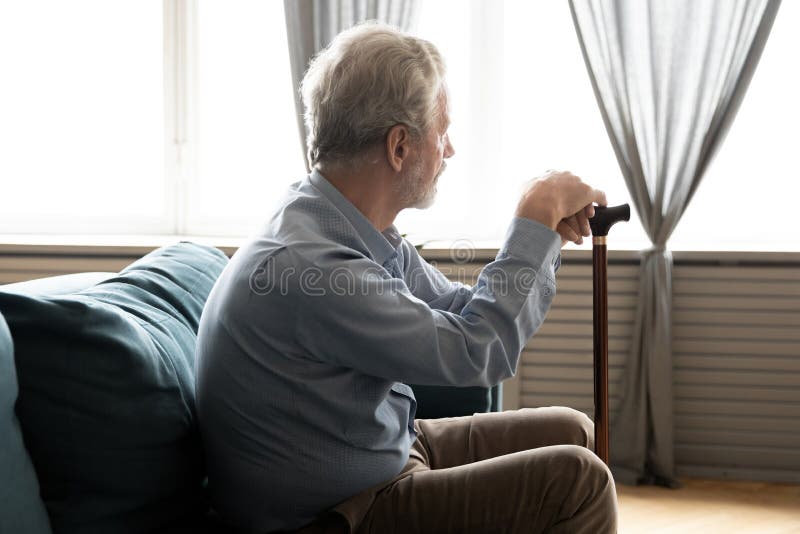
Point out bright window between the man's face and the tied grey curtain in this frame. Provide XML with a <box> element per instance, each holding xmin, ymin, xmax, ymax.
<box><xmin>403</xmin><ymin>0</ymin><xmax>645</xmax><ymax>248</ymax></box>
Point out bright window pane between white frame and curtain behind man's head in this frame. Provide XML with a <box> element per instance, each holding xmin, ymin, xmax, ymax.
<box><xmin>188</xmin><ymin>0</ymin><xmax>305</xmax><ymax>239</ymax></box>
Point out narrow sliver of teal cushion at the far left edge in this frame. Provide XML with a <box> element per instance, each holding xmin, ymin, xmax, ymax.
<box><xmin>0</xmin><ymin>315</ymin><xmax>50</xmax><ymax>534</ymax></box>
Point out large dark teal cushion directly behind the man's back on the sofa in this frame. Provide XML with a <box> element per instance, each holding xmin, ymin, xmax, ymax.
<box><xmin>0</xmin><ymin>243</ymin><xmax>227</xmax><ymax>534</ymax></box>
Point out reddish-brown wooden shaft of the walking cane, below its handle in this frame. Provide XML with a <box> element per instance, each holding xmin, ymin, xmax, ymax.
<box><xmin>592</xmin><ymin>242</ymin><xmax>608</xmax><ymax>464</ymax></box>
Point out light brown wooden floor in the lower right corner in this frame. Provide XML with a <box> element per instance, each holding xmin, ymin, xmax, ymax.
<box><xmin>617</xmin><ymin>479</ymin><xmax>800</xmax><ymax>534</ymax></box>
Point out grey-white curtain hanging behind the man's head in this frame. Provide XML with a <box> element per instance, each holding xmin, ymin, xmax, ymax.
<box><xmin>283</xmin><ymin>0</ymin><xmax>419</xmax><ymax>170</ymax></box>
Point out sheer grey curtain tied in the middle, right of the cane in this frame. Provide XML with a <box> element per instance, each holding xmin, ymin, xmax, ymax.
<box><xmin>570</xmin><ymin>0</ymin><xmax>780</xmax><ymax>485</ymax></box>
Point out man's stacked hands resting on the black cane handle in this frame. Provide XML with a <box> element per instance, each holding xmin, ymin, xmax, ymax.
<box><xmin>516</xmin><ymin>171</ymin><xmax>606</xmax><ymax>246</ymax></box>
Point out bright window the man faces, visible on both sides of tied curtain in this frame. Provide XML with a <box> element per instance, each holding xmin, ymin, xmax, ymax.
<box><xmin>406</xmin><ymin>0</ymin><xmax>800</xmax><ymax>250</ymax></box>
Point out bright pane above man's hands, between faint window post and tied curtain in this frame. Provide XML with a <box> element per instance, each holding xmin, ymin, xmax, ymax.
<box><xmin>504</xmin><ymin>0</ymin><xmax>647</xmax><ymax>248</ymax></box>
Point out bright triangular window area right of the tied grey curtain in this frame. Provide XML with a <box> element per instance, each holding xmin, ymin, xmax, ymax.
<box><xmin>670</xmin><ymin>2</ymin><xmax>800</xmax><ymax>252</ymax></box>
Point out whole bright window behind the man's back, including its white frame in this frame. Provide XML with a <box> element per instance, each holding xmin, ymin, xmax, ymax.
<box><xmin>0</xmin><ymin>0</ymin><xmax>305</xmax><ymax>239</ymax></box>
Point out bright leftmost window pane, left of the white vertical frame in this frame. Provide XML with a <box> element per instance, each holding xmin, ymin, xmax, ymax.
<box><xmin>0</xmin><ymin>0</ymin><xmax>166</xmax><ymax>234</ymax></box>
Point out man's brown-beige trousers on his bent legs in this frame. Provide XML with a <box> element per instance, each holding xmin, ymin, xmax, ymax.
<box><xmin>301</xmin><ymin>407</ymin><xmax>617</xmax><ymax>534</ymax></box>
